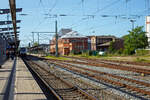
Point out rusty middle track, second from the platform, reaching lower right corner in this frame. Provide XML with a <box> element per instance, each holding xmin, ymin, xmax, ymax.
<box><xmin>44</xmin><ymin>61</ymin><xmax>150</xmax><ymax>99</ymax></box>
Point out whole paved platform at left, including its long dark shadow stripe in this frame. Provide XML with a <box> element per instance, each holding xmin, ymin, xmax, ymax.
<box><xmin>0</xmin><ymin>58</ymin><xmax>47</xmax><ymax>100</ymax></box>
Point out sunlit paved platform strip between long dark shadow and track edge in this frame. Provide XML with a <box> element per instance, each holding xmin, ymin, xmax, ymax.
<box><xmin>14</xmin><ymin>58</ymin><xmax>46</xmax><ymax>100</ymax></box>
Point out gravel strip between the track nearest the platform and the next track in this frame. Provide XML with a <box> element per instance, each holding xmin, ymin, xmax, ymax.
<box><xmin>46</xmin><ymin>61</ymin><xmax>127</xmax><ymax>100</ymax></box>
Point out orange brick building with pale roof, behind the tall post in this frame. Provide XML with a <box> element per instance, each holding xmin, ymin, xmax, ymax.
<box><xmin>50</xmin><ymin>31</ymin><xmax>88</xmax><ymax>55</ymax></box>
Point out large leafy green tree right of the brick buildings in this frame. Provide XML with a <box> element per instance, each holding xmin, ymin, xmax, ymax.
<box><xmin>123</xmin><ymin>26</ymin><xmax>148</xmax><ymax>55</ymax></box>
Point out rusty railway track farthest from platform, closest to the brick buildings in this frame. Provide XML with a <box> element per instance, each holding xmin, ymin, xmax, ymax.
<box><xmin>59</xmin><ymin>57</ymin><xmax>150</xmax><ymax>83</ymax></box>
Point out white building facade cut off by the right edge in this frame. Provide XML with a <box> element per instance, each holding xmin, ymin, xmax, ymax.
<box><xmin>146</xmin><ymin>16</ymin><xmax>150</xmax><ymax>48</ymax></box>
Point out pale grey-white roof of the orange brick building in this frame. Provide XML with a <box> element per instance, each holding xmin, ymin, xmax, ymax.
<box><xmin>61</xmin><ymin>31</ymin><xmax>87</xmax><ymax>38</ymax></box>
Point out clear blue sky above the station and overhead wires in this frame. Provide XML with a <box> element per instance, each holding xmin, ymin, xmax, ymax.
<box><xmin>0</xmin><ymin>0</ymin><xmax>150</xmax><ymax>46</ymax></box>
